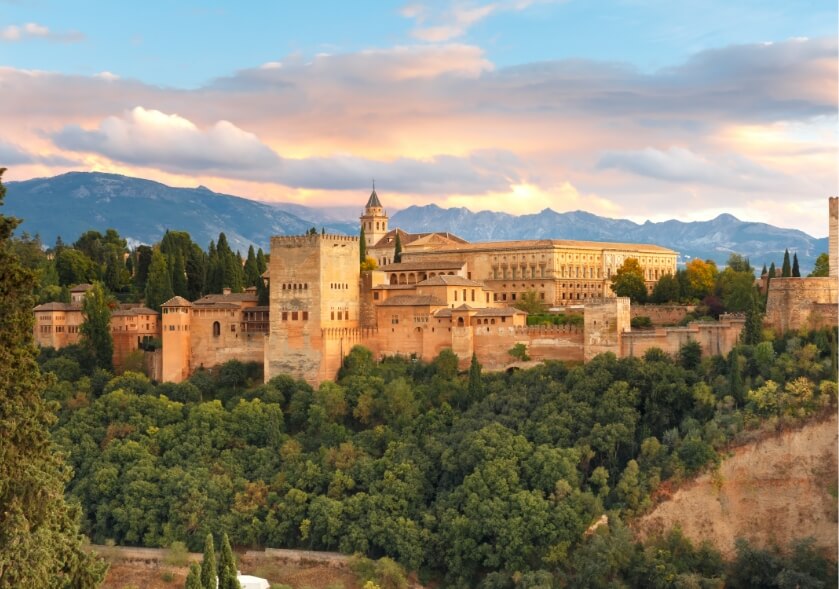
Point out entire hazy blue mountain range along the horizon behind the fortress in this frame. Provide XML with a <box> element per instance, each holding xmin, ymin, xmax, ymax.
<box><xmin>3</xmin><ymin>172</ymin><xmax>827</xmax><ymax>272</ymax></box>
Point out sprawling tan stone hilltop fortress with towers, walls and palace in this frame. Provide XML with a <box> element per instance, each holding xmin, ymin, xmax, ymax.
<box><xmin>35</xmin><ymin>190</ymin><xmax>839</xmax><ymax>385</ymax></box>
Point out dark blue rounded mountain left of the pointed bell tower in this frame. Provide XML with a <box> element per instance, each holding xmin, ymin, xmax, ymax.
<box><xmin>4</xmin><ymin>172</ymin><xmax>355</xmax><ymax>251</ymax></box>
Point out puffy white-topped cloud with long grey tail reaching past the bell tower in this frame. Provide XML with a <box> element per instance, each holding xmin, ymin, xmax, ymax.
<box><xmin>52</xmin><ymin>106</ymin><xmax>520</xmax><ymax>194</ymax></box>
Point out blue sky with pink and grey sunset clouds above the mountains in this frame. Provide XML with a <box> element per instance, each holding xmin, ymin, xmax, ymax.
<box><xmin>0</xmin><ymin>0</ymin><xmax>839</xmax><ymax>237</ymax></box>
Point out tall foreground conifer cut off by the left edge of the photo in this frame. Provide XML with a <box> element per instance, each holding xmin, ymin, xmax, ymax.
<box><xmin>0</xmin><ymin>168</ymin><xmax>107</xmax><ymax>589</ymax></box>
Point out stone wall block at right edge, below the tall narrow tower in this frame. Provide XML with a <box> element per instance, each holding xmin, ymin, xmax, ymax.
<box><xmin>765</xmin><ymin>276</ymin><xmax>839</xmax><ymax>332</ymax></box>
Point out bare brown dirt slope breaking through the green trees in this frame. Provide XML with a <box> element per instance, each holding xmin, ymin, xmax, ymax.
<box><xmin>636</xmin><ymin>415</ymin><xmax>839</xmax><ymax>556</ymax></box>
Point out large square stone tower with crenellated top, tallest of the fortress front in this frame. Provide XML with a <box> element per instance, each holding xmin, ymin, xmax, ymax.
<box><xmin>265</xmin><ymin>235</ymin><xmax>360</xmax><ymax>385</ymax></box>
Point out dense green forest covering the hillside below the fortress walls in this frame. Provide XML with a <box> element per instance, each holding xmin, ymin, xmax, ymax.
<box><xmin>39</xmin><ymin>331</ymin><xmax>837</xmax><ymax>588</ymax></box>
